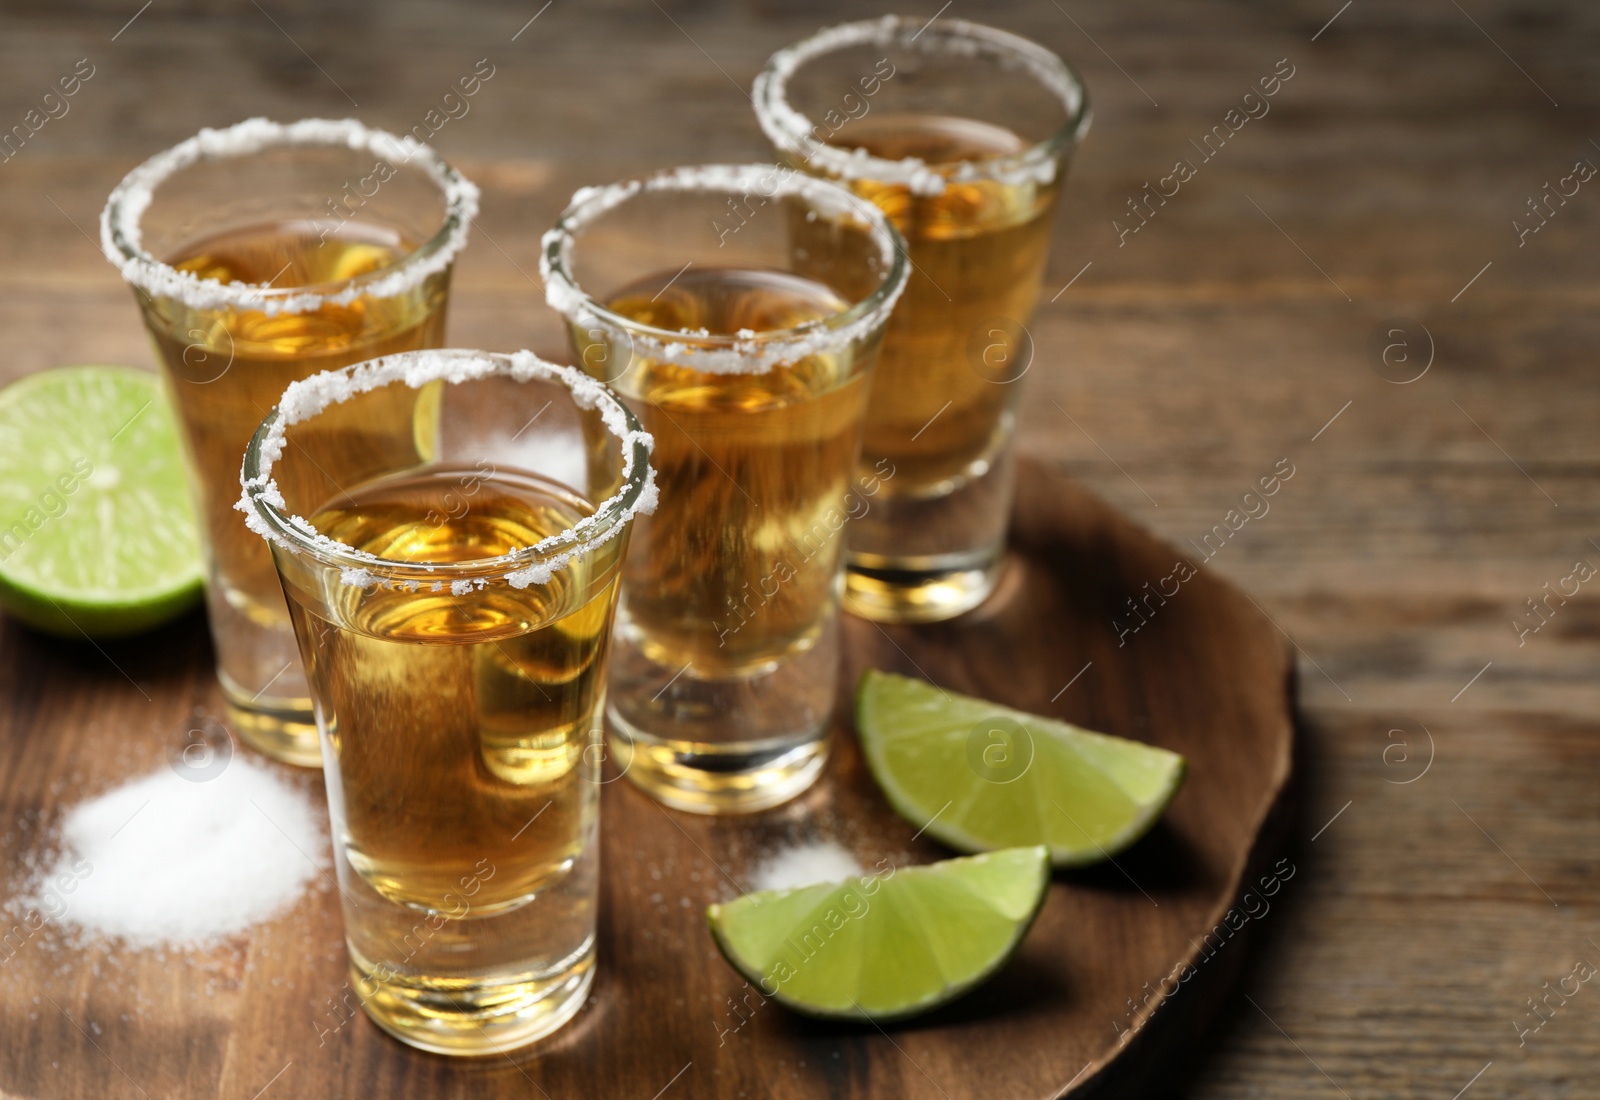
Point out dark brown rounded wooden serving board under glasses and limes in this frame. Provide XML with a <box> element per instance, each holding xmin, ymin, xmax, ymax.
<box><xmin>0</xmin><ymin>450</ymin><xmax>1293</xmax><ymax>1100</ymax></box>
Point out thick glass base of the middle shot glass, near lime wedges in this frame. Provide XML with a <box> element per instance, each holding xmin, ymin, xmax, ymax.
<box><xmin>606</xmin><ymin>722</ymin><xmax>830</xmax><ymax>814</ymax></box>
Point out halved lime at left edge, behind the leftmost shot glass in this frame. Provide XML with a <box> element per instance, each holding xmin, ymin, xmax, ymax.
<box><xmin>0</xmin><ymin>366</ymin><xmax>202</xmax><ymax>638</ymax></box>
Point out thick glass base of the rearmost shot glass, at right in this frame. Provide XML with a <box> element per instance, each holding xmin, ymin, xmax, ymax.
<box><xmin>845</xmin><ymin>544</ymin><xmax>1005</xmax><ymax>622</ymax></box>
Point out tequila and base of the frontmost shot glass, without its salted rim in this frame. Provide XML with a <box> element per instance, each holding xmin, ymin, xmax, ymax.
<box><xmin>280</xmin><ymin>460</ymin><xmax>621</xmax><ymax>1052</ymax></box>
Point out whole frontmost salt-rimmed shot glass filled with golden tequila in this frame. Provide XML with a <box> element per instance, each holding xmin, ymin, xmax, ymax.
<box><xmin>238</xmin><ymin>350</ymin><xmax>656</xmax><ymax>1054</ymax></box>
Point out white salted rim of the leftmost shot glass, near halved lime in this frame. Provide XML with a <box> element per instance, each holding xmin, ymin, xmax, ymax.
<box><xmin>101</xmin><ymin>118</ymin><xmax>478</xmax><ymax>317</ymax></box>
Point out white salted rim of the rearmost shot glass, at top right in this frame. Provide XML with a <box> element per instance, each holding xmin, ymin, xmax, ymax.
<box><xmin>752</xmin><ymin>16</ymin><xmax>1090</xmax><ymax>195</ymax></box>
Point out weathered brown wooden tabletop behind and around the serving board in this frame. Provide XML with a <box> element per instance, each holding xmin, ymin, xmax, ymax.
<box><xmin>0</xmin><ymin>0</ymin><xmax>1600</xmax><ymax>1098</ymax></box>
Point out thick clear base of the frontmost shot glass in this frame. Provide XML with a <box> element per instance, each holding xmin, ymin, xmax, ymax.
<box><xmin>350</xmin><ymin>937</ymin><xmax>595</xmax><ymax>1057</ymax></box>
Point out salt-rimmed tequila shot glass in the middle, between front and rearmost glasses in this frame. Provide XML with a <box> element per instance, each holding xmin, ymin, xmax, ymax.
<box><xmin>541</xmin><ymin>165</ymin><xmax>906</xmax><ymax>814</ymax></box>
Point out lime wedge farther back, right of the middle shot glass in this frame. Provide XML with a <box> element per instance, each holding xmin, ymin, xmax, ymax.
<box><xmin>856</xmin><ymin>670</ymin><xmax>1187</xmax><ymax>867</ymax></box>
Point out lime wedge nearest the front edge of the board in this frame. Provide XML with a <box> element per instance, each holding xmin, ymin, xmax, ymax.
<box><xmin>706</xmin><ymin>847</ymin><xmax>1050</xmax><ymax>1020</ymax></box>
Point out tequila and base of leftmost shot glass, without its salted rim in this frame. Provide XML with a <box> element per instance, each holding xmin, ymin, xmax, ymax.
<box><xmin>146</xmin><ymin>221</ymin><xmax>448</xmax><ymax>764</ymax></box>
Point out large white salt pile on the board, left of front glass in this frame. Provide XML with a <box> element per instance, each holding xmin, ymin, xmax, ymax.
<box><xmin>16</xmin><ymin>758</ymin><xmax>328</xmax><ymax>947</ymax></box>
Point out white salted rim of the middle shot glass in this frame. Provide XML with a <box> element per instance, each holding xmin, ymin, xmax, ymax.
<box><xmin>539</xmin><ymin>165</ymin><xmax>907</xmax><ymax>374</ymax></box>
